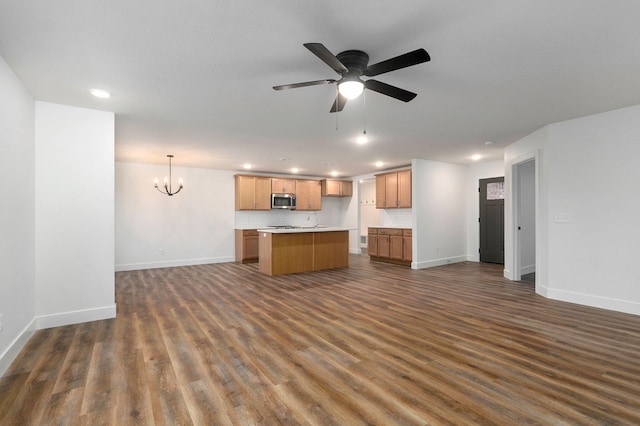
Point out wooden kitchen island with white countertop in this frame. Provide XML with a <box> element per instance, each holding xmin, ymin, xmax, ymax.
<box><xmin>258</xmin><ymin>227</ymin><xmax>349</xmax><ymax>275</ymax></box>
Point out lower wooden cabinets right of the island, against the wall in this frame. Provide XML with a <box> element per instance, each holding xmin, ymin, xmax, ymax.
<box><xmin>368</xmin><ymin>228</ymin><xmax>412</xmax><ymax>265</ymax></box>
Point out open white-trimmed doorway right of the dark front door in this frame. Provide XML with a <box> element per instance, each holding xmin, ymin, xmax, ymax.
<box><xmin>513</xmin><ymin>158</ymin><xmax>536</xmax><ymax>282</ymax></box>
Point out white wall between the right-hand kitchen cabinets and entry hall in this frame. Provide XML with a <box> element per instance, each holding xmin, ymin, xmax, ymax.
<box><xmin>411</xmin><ymin>160</ymin><xmax>468</xmax><ymax>269</ymax></box>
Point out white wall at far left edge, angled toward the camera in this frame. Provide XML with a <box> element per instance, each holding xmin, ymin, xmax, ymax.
<box><xmin>0</xmin><ymin>52</ymin><xmax>36</xmax><ymax>375</ymax></box>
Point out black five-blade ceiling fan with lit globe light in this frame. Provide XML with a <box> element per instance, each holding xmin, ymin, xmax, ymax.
<box><xmin>273</xmin><ymin>43</ymin><xmax>431</xmax><ymax>112</ymax></box>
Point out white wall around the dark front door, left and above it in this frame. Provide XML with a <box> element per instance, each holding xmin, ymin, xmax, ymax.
<box><xmin>465</xmin><ymin>161</ymin><xmax>504</xmax><ymax>262</ymax></box>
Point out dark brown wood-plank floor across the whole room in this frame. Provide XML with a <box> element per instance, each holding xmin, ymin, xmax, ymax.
<box><xmin>0</xmin><ymin>255</ymin><xmax>640</xmax><ymax>425</ymax></box>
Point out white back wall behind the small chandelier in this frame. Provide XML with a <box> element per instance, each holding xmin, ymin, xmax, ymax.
<box><xmin>115</xmin><ymin>163</ymin><xmax>235</xmax><ymax>271</ymax></box>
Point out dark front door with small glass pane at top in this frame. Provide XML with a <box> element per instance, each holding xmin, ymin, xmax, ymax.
<box><xmin>480</xmin><ymin>176</ymin><xmax>504</xmax><ymax>263</ymax></box>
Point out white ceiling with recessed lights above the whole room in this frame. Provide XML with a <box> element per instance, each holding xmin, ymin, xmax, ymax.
<box><xmin>0</xmin><ymin>0</ymin><xmax>640</xmax><ymax>176</ymax></box>
